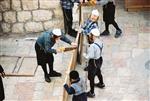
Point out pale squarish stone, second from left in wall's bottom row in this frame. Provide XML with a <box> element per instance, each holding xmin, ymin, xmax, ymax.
<box><xmin>12</xmin><ymin>23</ymin><xmax>24</xmax><ymax>33</ymax></box>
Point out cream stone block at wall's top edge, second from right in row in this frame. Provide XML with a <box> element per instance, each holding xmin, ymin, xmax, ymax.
<box><xmin>22</xmin><ymin>0</ymin><xmax>38</xmax><ymax>10</ymax></box>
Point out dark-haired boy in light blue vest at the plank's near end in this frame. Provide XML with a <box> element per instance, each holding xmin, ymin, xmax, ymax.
<box><xmin>64</xmin><ymin>70</ymin><xmax>87</xmax><ymax>101</ymax></box>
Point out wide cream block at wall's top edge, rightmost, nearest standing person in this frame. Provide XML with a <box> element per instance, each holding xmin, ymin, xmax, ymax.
<box><xmin>39</xmin><ymin>0</ymin><xmax>60</xmax><ymax>9</ymax></box>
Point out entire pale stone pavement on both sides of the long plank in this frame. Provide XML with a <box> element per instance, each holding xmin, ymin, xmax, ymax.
<box><xmin>0</xmin><ymin>1</ymin><xmax>150</xmax><ymax>101</ymax></box>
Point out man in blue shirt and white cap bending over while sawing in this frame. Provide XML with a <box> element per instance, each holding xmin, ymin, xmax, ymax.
<box><xmin>35</xmin><ymin>29</ymin><xmax>76</xmax><ymax>82</ymax></box>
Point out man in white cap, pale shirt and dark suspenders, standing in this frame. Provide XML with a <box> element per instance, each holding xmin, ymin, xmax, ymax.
<box><xmin>83</xmin><ymin>28</ymin><xmax>105</xmax><ymax>97</ymax></box>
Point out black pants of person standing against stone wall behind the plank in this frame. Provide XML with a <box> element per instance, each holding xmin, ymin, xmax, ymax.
<box><xmin>62</xmin><ymin>7</ymin><xmax>73</xmax><ymax>34</ymax></box>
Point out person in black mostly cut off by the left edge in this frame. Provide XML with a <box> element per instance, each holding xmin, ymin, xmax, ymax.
<box><xmin>0</xmin><ymin>65</ymin><xmax>5</xmax><ymax>101</ymax></box>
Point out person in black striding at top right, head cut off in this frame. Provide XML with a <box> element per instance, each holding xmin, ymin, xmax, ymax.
<box><xmin>99</xmin><ymin>0</ymin><xmax>122</xmax><ymax>38</ymax></box>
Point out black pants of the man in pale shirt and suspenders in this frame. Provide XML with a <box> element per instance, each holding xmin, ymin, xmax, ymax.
<box><xmin>88</xmin><ymin>57</ymin><xmax>103</xmax><ymax>93</ymax></box>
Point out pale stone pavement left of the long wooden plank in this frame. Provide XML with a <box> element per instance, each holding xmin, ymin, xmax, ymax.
<box><xmin>0</xmin><ymin>35</ymin><xmax>74</xmax><ymax>101</ymax></box>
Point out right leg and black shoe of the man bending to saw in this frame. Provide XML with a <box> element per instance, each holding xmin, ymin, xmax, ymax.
<box><xmin>48</xmin><ymin>54</ymin><xmax>61</xmax><ymax>77</ymax></box>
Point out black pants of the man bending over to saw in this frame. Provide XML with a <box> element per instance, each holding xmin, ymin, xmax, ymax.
<box><xmin>35</xmin><ymin>43</ymin><xmax>54</xmax><ymax>75</ymax></box>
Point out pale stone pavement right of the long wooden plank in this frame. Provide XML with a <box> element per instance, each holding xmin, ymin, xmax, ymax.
<box><xmin>70</xmin><ymin>1</ymin><xmax>150</xmax><ymax>101</ymax></box>
